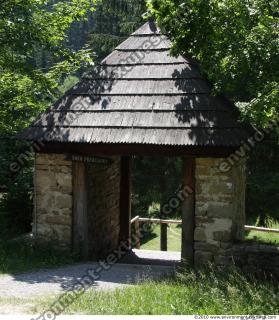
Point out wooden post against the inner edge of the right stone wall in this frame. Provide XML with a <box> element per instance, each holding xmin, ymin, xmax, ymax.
<box><xmin>181</xmin><ymin>158</ymin><xmax>196</xmax><ymax>265</ymax></box>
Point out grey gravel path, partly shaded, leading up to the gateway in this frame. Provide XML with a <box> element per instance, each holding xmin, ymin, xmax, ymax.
<box><xmin>0</xmin><ymin>263</ymin><xmax>174</xmax><ymax>299</ymax></box>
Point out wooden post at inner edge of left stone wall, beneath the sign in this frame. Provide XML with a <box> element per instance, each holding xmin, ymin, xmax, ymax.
<box><xmin>73</xmin><ymin>162</ymin><xmax>89</xmax><ymax>259</ymax></box>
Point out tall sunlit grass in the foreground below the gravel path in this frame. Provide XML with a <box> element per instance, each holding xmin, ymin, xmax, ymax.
<box><xmin>32</xmin><ymin>269</ymin><xmax>279</xmax><ymax>315</ymax></box>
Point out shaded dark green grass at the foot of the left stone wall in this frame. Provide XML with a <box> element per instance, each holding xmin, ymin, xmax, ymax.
<box><xmin>0</xmin><ymin>238</ymin><xmax>77</xmax><ymax>275</ymax></box>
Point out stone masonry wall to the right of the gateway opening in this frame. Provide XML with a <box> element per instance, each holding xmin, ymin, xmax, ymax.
<box><xmin>194</xmin><ymin>158</ymin><xmax>245</xmax><ymax>266</ymax></box>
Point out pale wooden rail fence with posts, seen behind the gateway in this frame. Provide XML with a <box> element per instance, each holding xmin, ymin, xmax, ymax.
<box><xmin>131</xmin><ymin>216</ymin><xmax>279</xmax><ymax>251</ymax></box>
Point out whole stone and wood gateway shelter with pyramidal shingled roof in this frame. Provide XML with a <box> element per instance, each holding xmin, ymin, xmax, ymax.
<box><xmin>21</xmin><ymin>21</ymin><xmax>248</xmax><ymax>263</ymax></box>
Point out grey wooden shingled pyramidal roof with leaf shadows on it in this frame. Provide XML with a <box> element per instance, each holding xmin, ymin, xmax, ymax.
<box><xmin>20</xmin><ymin>21</ymin><xmax>252</xmax><ymax>147</ymax></box>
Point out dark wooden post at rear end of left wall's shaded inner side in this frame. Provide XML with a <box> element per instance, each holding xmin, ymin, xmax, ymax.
<box><xmin>119</xmin><ymin>156</ymin><xmax>131</xmax><ymax>245</ymax></box>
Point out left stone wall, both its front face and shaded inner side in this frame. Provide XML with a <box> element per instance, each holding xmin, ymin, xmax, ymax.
<box><xmin>33</xmin><ymin>154</ymin><xmax>120</xmax><ymax>255</ymax></box>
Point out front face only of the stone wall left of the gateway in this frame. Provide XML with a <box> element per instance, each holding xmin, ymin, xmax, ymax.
<box><xmin>33</xmin><ymin>154</ymin><xmax>72</xmax><ymax>249</ymax></box>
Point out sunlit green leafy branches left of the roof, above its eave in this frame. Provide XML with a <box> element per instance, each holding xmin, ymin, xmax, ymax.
<box><xmin>0</xmin><ymin>0</ymin><xmax>96</xmax><ymax>135</ymax></box>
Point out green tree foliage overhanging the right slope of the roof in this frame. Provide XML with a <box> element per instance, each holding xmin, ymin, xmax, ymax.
<box><xmin>148</xmin><ymin>0</ymin><xmax>279</xmax><ymax>126</ymax></box>
